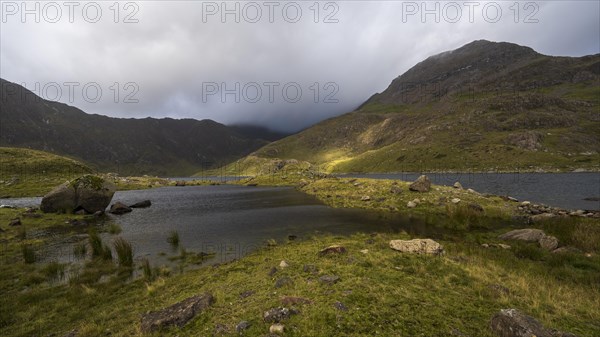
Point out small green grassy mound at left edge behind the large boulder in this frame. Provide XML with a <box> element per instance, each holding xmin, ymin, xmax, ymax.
<box><xmin>0</xmin><ymin>147</ymin><xmax>92</xmax><ymax>197</ymax></box>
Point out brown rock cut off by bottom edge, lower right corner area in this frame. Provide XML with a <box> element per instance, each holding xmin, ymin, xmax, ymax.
<box><xmin>490</xmin><ymin>309</ymin><xmax>577</xmax><ymax>337</ymax></box>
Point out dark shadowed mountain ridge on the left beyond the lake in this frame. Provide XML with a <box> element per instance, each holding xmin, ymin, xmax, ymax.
<box><xmin>0</xmin><ymin>80</ymin><xmax>267</xmax><ymax>175</ymax></box>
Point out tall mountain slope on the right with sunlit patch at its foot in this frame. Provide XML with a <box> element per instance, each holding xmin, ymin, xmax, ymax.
<box><xmin>232</xmin><ymin>41</ymin><xmax>600</xmax><ymax>172</ymax></box>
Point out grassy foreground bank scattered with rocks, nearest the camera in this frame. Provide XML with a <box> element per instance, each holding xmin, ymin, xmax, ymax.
<box><xmin>0</xmin><ymin>203</ymin><xmax>600</xmax><ymax>337</ymax></box>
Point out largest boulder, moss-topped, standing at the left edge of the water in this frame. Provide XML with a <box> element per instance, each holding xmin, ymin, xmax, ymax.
<box><xmin>40</xmin><ymin>175</ymin><xmax>117</xmax><ymax>213</ymax></box>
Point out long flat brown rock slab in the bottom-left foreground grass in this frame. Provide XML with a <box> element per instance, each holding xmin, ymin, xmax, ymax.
<box><xmin>141</xmin><ymin>293</ymin><xmax>215</xmax><ymax>333</ymax></box>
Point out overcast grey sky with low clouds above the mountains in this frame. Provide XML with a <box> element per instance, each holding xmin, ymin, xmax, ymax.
<box><xmin>0</xmin><ymin>0</ymin><xmax>600</xmax><ymax>131</ymax></box>
